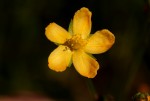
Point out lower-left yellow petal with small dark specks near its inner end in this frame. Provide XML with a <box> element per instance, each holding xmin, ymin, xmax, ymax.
<box><xmin>48</xmin><ymin>45</ymin><xmax>72</xmax><ymax>72</ymax></box>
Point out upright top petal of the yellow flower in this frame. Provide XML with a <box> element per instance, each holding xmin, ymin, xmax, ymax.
<box><xmin>73</xmin><ymin>7</ymin><xmax>92</xmax><ymax>39</ymax></box>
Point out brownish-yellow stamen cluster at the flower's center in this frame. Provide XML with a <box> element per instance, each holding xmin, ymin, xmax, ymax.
<box><xmin>64</xmin><ymin>34</ymin><xmax>87</xmax><ymax>51</ymax></box>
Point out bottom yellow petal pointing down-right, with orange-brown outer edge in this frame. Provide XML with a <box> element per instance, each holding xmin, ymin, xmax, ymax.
<box><xmin>73</xmin><ymin>50</ymin><xmax>99</xmax><ymax>78</ymax></box>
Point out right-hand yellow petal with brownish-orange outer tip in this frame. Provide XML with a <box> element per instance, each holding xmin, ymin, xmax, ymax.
<box><xmin>84</xmin><ymin>29</ymin><xmax>115</xmax><ymax>54</ymax></box>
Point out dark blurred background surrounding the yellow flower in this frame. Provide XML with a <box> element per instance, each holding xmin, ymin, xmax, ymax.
<box><xmin>0</xmin><ymin>0</ymin><xmax>150</xmax><ymax>101</ymax></box>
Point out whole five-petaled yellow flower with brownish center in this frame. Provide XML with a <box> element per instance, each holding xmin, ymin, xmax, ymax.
<box><xmin>45</xmin><ymin>7</ymin><xmax>115</xmax><ymax>78</ymax></box>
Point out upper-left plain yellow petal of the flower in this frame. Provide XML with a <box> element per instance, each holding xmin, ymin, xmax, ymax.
<box><xmin>45</xmin><ymin>23</ymin><xmax>71</xmax><ymax>44</ymax></box>
